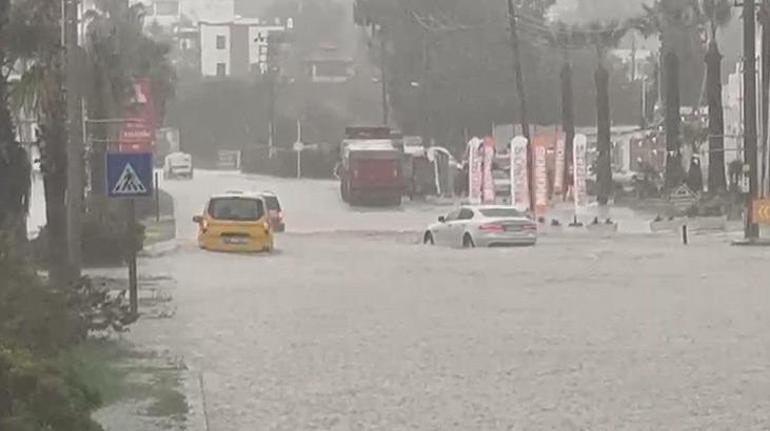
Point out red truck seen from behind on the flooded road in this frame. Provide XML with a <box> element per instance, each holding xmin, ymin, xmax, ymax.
<box><xmin>339</xmin><ymin>127</ymin><xmax>404</xmax><ymax>206</ymax></box>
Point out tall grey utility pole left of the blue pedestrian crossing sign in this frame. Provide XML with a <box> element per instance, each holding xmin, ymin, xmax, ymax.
<box><xmin>62</xmin><ymin>0</ymin><xmax>85</xmax><ymax>277</ymax></box>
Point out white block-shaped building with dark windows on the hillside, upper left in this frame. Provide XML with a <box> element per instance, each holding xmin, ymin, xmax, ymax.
<box><xmin>198</xmin><ymin>18</ymin><xmax>293</xmax><ymax>78</ymax></box>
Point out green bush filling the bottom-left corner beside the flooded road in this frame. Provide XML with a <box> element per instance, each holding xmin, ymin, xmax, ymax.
<box><xmin>0</xmin><ymin>238</ymin><xmax>134</xmax><ymax>431</ymax></box>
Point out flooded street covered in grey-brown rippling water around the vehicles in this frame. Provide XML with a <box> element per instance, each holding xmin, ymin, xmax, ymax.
<box><xmin>97</xmin><ymin>172</ymin><xmax>770</xmax><ymax>431</ymax></box>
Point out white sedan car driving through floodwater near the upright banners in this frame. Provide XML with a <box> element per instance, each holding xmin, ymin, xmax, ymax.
<box><xmin>423</xmin><ymin>205</ymin><xmax>537</xmax><ymax>248</ymax></box>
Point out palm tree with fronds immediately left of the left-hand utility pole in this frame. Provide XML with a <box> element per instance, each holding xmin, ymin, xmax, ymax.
<box><xmin>8</xmin><ymin>0</ymin><xmax>73</xmax><ymax>286</ymax></box>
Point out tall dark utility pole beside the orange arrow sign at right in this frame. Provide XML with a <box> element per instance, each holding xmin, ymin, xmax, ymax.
<box><xmin>743</xmin><ymin>0</ymin><xmax>759</xmax><ymax>240</ymax></box>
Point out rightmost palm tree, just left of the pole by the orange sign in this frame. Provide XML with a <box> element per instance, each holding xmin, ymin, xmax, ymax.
<box><xmin>701</xmin><ymin>0</ymin><xmax>732</xmax><ymax>193</ymax></box>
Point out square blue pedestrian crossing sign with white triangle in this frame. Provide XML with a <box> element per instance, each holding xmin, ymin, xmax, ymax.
<box><xmin>107</xmin><ymin>153</ymin><xmax>153</xmax><ymax>198</ymax></box>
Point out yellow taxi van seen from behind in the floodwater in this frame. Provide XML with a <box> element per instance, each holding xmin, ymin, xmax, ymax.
<box><xmin>193</xmin><ymin>191</ymin><xmax>274</xmax><ymax>253</ymax></box>
